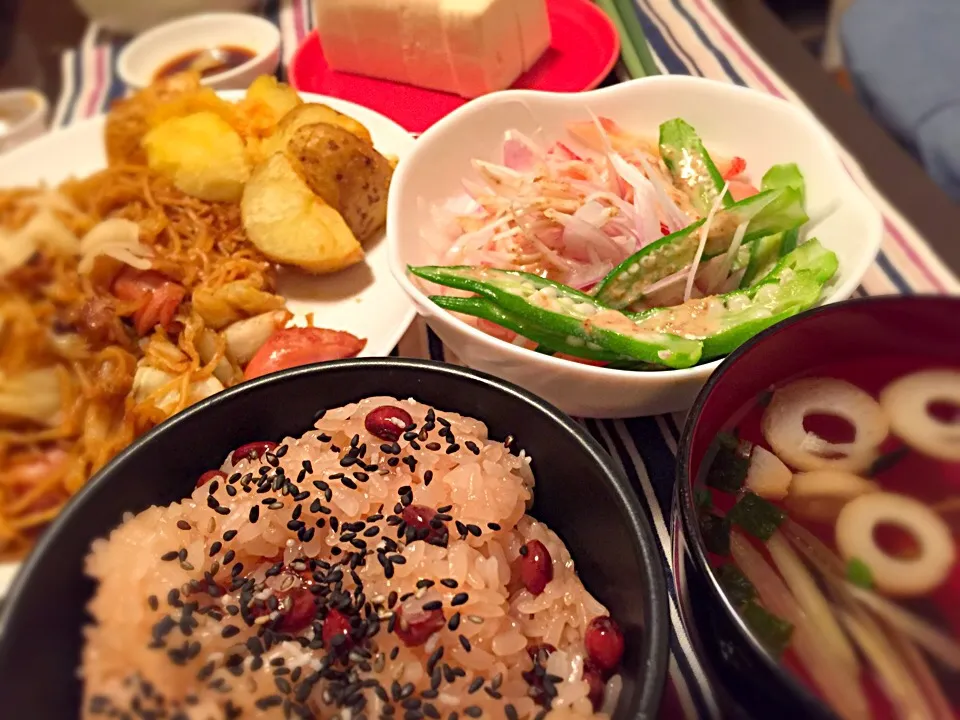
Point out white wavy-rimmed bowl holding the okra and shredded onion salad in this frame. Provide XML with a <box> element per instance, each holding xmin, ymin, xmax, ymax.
<box><xmin>387</xmin><ymin>76</ymin><xmax>883</xmax><ymax>418</ymax></box>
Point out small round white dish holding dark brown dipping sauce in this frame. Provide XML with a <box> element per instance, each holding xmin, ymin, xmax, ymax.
<box><xmin>117</xmin><ymin>13</ymin><xmax>280</xmax><ymax>90</ymax></box>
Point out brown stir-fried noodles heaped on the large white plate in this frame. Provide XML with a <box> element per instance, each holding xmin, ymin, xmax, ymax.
<box><xmin>0</xmin><ymin>166</ymin><xmax>284</xmax><ymax>555</ymax></box>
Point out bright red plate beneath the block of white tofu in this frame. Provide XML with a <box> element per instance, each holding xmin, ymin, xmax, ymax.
<box><xmin>287</xmin><ymin>0</ymin><xmax>620</xmax><ymax>133</ymax></box>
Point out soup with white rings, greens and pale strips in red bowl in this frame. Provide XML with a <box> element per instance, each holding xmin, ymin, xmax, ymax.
<box><xmin>695</xmin><ymin>355</ymin><xmax>960</xmax><ymax>719</ymax></box>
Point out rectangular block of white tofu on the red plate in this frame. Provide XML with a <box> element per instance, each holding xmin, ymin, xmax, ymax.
<box><xmin>315</xmin><ymin>0</ymin><xmax>550</xmax><ymax>98</ymax></box>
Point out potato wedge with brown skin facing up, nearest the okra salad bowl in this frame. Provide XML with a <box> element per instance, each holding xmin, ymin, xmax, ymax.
<box><xmin>287</xmin><ymin>123</ymin><xmax>393</xmax><ymax>242</ymax></box>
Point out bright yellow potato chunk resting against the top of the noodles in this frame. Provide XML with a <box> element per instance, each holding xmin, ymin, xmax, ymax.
<box><xmin>143</xmin><ymin>112</ymin><xmax>250</xmax><ymax>202</ymax></box>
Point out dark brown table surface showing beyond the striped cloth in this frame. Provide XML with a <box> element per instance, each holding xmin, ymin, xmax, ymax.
<box><xmin>0</xmin><ymin>0</ymin><xmax>960</xmax><ymax>273</ymax></box>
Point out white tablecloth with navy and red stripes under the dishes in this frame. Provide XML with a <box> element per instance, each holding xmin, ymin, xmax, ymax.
<box><xmin>54</xmin><ymin>0</ymin><xmax>960</xmax><ymax>718</ymax></box>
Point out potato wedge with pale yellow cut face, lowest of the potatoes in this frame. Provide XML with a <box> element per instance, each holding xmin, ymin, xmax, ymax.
<box><xmin>240</xmin><ymin>153</ymin><xmax>363</xmax><ymax>273</ymax></box>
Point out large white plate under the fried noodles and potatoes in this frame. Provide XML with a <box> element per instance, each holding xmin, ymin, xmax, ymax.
<box><xmin>0</xmin><ymin>91</ymin><xmax>416</xmax><ymax>598</ymax></box>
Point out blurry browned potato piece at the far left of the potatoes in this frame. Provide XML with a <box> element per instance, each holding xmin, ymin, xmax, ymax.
<box><xmin>104</xmin><ymin>73</ymin><xmax>200</xmax><ymax>165</ymax></box>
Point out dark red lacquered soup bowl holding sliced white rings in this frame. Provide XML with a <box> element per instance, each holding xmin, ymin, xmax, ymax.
<box><xmin>672</xmin><ymin>296</ymin><xmax>960</xmax><ymax>718</ymax></box>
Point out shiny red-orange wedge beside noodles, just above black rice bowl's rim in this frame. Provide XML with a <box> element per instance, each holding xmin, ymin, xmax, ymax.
<box><xmin>243</xmin><ymin>328</ymin><xmax>367</xmax><ymax>380</ymax></box>
